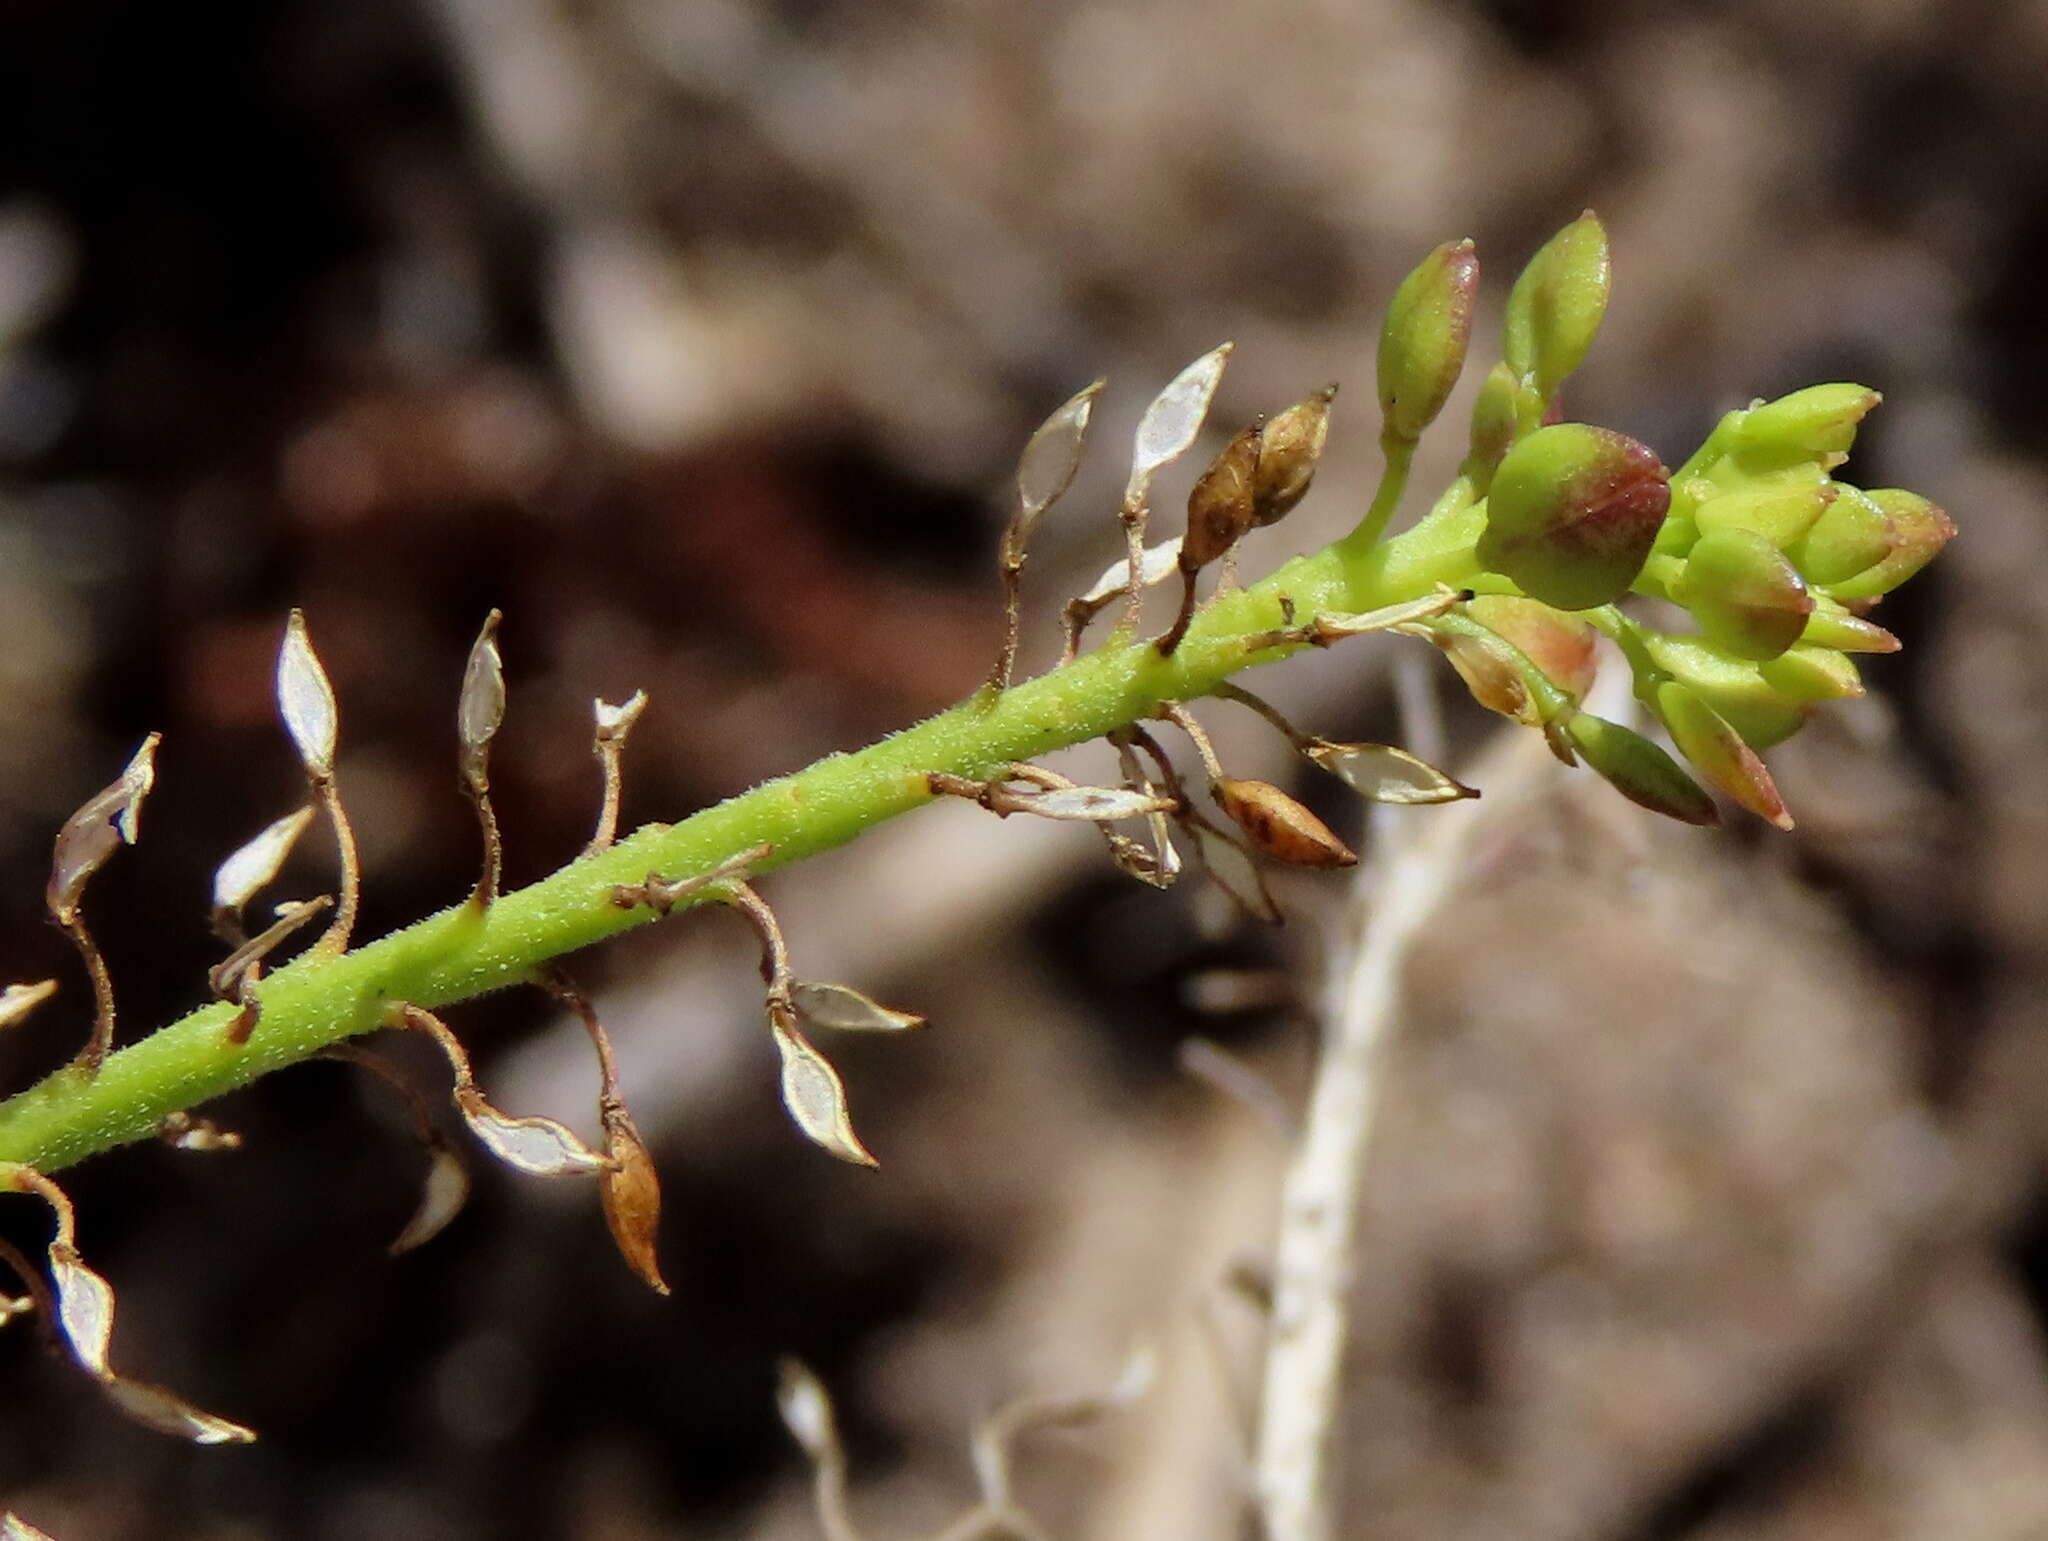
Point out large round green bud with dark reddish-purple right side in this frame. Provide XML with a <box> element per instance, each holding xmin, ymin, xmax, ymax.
<box><xmin>1479</xmin><ymin>422</ymin><xmax>1671</xmax><ymax>611</ymax></box>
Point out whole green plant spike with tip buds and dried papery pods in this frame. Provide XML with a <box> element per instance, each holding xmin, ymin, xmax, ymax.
<box><xmin>0</xmin><ymin>213</ymin><xmax>1954</xmax><ymax>1535</ymax></box>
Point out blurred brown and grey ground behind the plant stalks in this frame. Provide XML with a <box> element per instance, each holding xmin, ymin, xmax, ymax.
<box><xmin>0</xmin><ymin>0</ymin><xmax>2048</xmax><ymax>1541</ymax></box>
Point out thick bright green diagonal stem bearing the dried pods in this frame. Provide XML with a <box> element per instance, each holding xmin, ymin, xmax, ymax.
<box><xmin>0</xmin><ymin>518</ymin><xmax>1470</xmax><ymax>1172</ymax></box>
